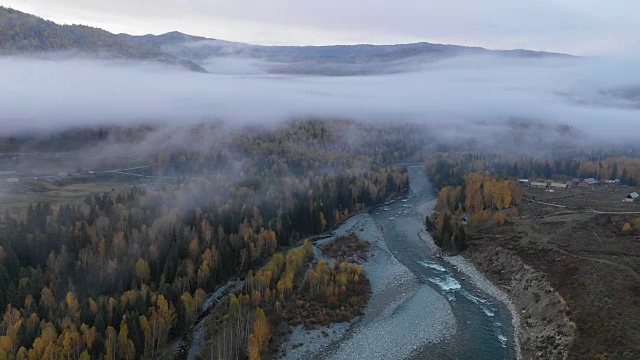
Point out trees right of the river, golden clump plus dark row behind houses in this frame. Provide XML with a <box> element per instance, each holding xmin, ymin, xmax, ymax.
<box><xmin>425</xmin><ymin>150</ymin><xmax>640</xmax><ymax>251</ymax></box>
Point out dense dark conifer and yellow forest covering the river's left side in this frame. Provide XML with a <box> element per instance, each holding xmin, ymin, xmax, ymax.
<box><xmin>0</xmin><ymin>121</ymin><xmax>420</xmax><ymax>359</ymax></box>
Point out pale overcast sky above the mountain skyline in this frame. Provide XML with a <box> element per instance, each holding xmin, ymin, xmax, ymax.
<box><xmin>0</xmin><ymin>0</ymin><xmax>640</xmax><ymax>55</ymax></box>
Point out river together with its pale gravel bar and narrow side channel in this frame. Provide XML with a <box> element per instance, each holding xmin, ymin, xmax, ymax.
<box><xmin>177</xmin><ymin>166</ymin><xmax>516</xmax><ymax>360</ymax></box>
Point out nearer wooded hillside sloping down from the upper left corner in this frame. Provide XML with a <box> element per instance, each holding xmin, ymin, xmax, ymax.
<box><xmin>0</xmin><ymin>7</ymin><xmax>205</xmax><ymax>72</ymax></box>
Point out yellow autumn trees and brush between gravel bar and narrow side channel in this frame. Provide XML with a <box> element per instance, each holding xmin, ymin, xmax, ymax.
<box><xmin>200</xmin><ymin>241</ymin><xmax>370</xmax><ymax>359</ymax></box>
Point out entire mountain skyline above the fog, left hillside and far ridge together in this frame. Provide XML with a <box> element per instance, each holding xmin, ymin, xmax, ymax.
<box><xmin>0</xmin><ymin>7</ymin><xmax>570</xmax><ymax>76</ymax></box>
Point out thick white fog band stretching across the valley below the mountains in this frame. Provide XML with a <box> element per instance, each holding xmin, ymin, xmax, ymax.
<box><xmin>0</xmin><ymin>56</ymin><xmax>640</xmax><ymax>140</ymax></box>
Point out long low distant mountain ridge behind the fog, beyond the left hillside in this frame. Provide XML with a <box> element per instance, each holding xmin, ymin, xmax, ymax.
<box><xmin>119</xmin><ymin>32</ymin><xmax>570</xmax><ymax>75</ymax></box>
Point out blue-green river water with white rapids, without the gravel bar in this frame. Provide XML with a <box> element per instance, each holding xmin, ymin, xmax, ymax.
<box><xmin>370</xmin><ymin>166</ymin><xmax>516</xmax><ymax>360</ymax></box>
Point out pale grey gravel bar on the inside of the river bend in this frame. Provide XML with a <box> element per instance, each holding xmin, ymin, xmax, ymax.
<box><xmin>282</xmin><ymin>213</ymin><xmax>456</xmax><ymax>360</ymax></box>
